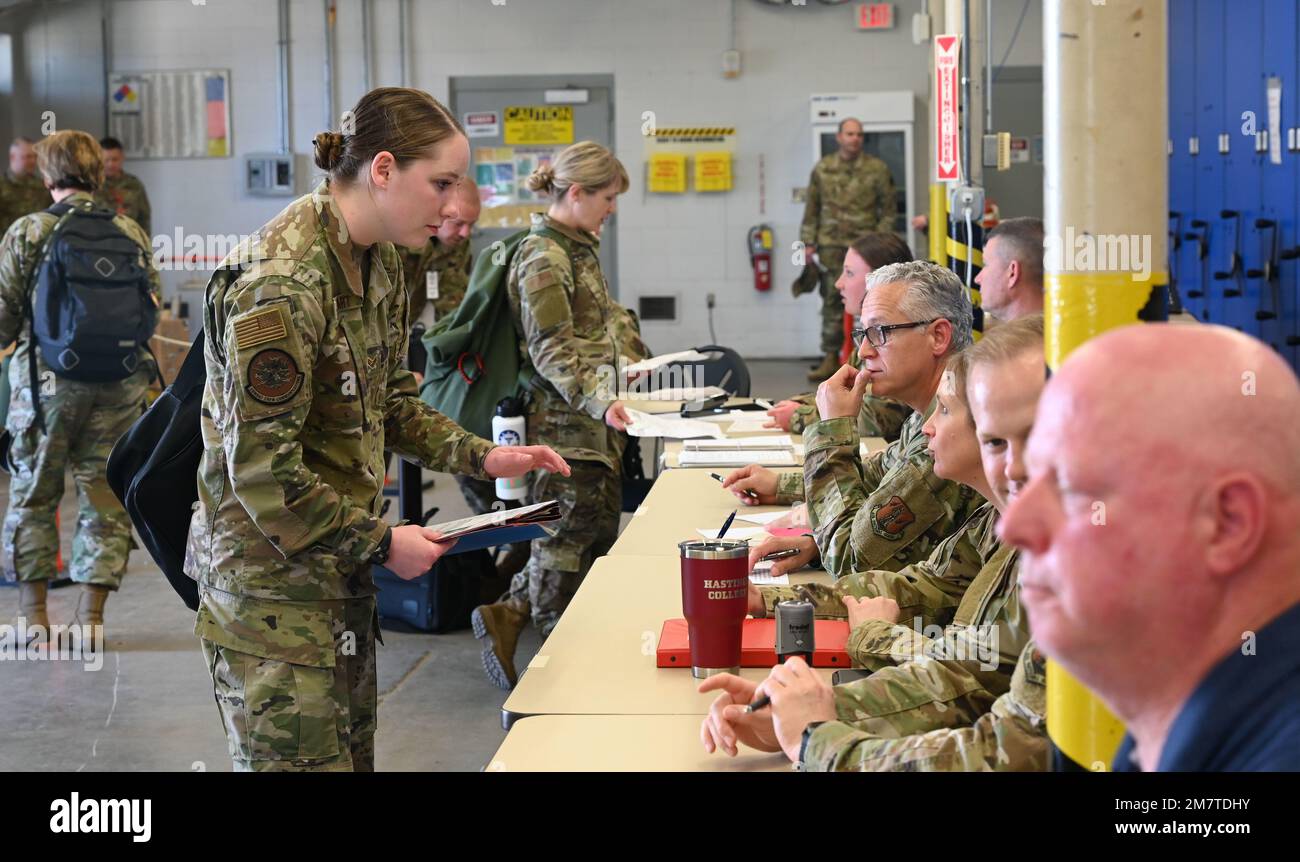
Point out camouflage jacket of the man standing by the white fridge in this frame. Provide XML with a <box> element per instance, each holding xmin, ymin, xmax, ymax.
<box><xmin>800</xmin><ymin>152</ymin><xmax>898</xmax><ymax>248</ymax></box>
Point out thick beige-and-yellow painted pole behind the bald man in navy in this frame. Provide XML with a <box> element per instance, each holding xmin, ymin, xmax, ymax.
<box><xmin>1043</xmin><ymin>0</ymin><xmax>1169</xmax><ymax>771</ymax></box>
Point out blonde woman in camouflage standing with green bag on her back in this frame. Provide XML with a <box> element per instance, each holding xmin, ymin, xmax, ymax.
<box><xmin>472</xmin><ymin>140</ymin><xmax>644</xmax><ymax>688</ymax></box>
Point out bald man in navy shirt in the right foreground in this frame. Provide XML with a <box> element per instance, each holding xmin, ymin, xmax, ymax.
<box><xmin>1001</xmin><ymin>324</ymin><xmax>1300</xmax><ymax>771</ymax></box>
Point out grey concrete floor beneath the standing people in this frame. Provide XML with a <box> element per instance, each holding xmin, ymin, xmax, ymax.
<box><xmin>0</xmin><ymin>360</ymin><xmax>811</xmax><ymax>771</ymax></box>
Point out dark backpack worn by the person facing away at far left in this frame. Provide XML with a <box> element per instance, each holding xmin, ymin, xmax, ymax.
<box><xmin>27</xmin><ymin>202</ymin><xmax>159</xmax><ymax>430</ymax></box>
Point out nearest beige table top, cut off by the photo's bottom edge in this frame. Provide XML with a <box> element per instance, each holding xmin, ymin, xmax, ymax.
<box><xmin>485</xmin><ymin>715</ymin><xmax>794</xmax><ymax>772</ymax></box>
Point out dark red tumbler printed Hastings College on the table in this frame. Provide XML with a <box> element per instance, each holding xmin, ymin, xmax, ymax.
<box><xmin>677</xmin><ymin>540</ymin><xmax>749</xmax><ymax>679</ymax></box>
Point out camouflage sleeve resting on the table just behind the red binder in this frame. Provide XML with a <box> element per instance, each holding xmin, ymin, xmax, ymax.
<box><xmin>759</xmin><ymin>503</ymin><xmax>1001</xmax><ymax>629</ymax></box>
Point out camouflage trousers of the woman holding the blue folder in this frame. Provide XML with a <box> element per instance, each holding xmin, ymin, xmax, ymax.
<box><xmin>200</xmin><ymin>595</ymin><xmax>378</xmax><ymax>772</ymax></box>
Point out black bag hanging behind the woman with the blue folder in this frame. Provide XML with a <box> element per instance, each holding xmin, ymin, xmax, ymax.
<box><xmin>107</xmin><ymin>332</ymin><xmax>208</xmax><ymax>611</ymax></box>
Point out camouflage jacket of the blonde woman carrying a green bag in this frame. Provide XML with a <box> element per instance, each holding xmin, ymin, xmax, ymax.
<box><xmin>506</xmin><ymin>213</ymin><xmax>629</xmax><ymax>469</ymax></box>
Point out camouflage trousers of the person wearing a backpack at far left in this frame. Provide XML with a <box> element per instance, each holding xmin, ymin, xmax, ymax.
<box><xmin>3</xmin><ymin>358</ymin><xmax>152</xmax><ymax>590</ymax></box>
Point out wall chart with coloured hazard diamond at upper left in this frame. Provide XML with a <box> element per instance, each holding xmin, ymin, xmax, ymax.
<box><xmin>108</xmin><ymin>69</ymin><xmax>234</xmax><ymax>159</ymax></box>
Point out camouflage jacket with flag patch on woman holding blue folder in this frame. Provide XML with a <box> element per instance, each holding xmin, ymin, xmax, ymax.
<box><xmin>186</xmin><ymin>183</ymin><xmax>493</xmax><ymax>613</ymax></box>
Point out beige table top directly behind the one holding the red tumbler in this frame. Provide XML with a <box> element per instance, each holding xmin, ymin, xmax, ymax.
<box><xmin>610</xmin><ymin>468</ymin><xmax>785</xmax><ymax>560</ymax></box>
